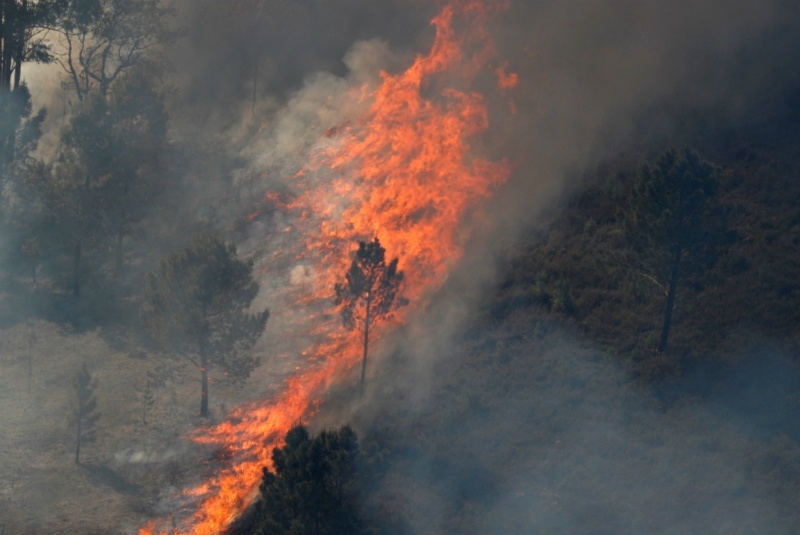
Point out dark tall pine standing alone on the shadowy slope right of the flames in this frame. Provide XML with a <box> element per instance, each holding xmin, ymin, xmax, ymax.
<box><xmin>633</xmin><ymin>149</ymin><xmax>719</xmax><ymax>353</ymax></box>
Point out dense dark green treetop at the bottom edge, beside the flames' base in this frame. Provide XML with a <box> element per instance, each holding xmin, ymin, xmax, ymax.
<box><xmin>252</xmin><ymin>426</ymin><xmax>363</xmax><ymax>535</ymax></box>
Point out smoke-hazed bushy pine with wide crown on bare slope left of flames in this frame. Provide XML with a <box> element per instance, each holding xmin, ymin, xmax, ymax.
<box><xmin>141</xmin><ymin>235</ymin><xmax>269</xmax><ymax>417</ymax></box>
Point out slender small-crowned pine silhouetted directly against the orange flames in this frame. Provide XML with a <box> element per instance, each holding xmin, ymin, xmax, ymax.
<box><xmin>336</xmin><ymin>238</ymin><xmax>408</xmax><ymax>385</ymax></box>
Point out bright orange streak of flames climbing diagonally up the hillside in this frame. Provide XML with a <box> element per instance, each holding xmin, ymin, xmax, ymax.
<box><xmin>139</xmin><ymin>0</ymin><xmax>516</xmax><ymax>535</ymax></box>
